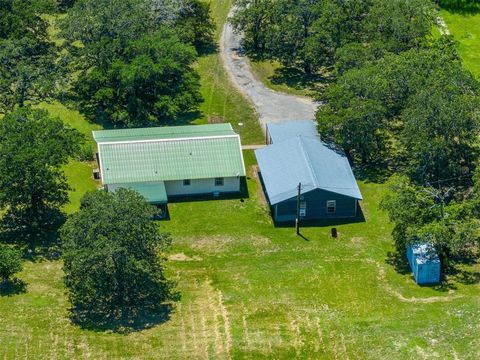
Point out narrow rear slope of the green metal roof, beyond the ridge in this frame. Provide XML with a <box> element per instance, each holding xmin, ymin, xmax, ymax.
<box><xmin>93</xmin><ymin>123</ymin><xmax>235</xmax><ymax>143</ymax></box>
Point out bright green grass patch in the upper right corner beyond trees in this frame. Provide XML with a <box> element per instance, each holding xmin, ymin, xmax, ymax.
<box><xmin>440</xmin><ymin>0</ymin><xmax>480</xmax><ymax>79</ymax></box>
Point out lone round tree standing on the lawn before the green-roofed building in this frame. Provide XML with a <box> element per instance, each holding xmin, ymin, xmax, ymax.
<box><xmin>61</xmin><ymin>189</ymin><xmax>173</xmax><ymax>324</ymax></box>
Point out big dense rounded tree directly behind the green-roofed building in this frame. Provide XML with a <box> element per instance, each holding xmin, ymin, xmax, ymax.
<box><xmin>61</xmin><ymin>0</ymin><xmax>209</xmax><ymax>126</ymax></box>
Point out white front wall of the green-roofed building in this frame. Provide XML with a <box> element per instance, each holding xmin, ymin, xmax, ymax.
<box><xmin>165</xmin><ymin>176</ymin><xmax>240</xmax><ymax>196</ymax></box>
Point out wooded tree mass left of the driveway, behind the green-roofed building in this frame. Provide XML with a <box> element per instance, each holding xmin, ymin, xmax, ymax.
<box><xmin>0</xmin><ymin>0</ymin><xmax>214</xmax><ymax>126</ymax></box>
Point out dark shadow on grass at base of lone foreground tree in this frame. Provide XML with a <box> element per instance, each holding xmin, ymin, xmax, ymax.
<box><xmin>70</xmin><ymin>304</ymin><xmax>173</xmax><ymax>334</ymax></box>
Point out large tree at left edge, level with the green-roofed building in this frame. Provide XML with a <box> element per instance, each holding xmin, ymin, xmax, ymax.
<box><xmin>0</xmin><ymin>107</ymin><xmax>83</xmax><ymax>240</ymax></box>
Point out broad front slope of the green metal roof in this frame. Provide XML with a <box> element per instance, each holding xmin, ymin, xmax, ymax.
<box><xmin>94</xmin><ymin>124</ymin><xmax>245</xmax><ymax>184</ymax></box>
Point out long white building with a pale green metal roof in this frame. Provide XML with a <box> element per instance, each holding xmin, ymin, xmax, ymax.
<box><xmin>93</xmin><ymin>124</ymin><xmax>245</xmax><ymax>204</ymax></box>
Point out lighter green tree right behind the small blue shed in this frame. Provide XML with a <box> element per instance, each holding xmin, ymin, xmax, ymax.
<box><xmin>382</xmin><ymin>172</ymin><xmax>480</xmax><ymax>265</ymax></box>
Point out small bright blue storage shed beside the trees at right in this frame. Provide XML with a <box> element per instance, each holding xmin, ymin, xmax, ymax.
<box><xmin>407</xmin><ymin>243</ymin><xmax>441</xmax><ymax>285</ymax></box>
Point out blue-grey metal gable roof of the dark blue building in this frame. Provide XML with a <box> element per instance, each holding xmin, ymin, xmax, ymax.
<box><xmin>255</xmin><ymin>136</ymin><xmax>362</xmax><ymax>205</ymax></box>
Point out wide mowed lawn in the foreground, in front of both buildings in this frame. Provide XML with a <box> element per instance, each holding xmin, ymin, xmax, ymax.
<box><xmin>0</xmin><ymin>151</ymin><xmax>480</xmax><ymax>359</ymax></box>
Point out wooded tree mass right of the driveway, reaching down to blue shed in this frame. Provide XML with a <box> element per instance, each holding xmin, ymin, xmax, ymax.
<box><xmin>232</xmin><ymin>0</ymin><xmax>480</xmax><ymax>268</ymax></box>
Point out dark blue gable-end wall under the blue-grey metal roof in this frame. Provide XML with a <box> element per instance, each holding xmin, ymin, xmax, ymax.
<box><xmin>272</xmin><ymin>189</ymin><xmax>358</xmax><ymax>221</ymax></box>
